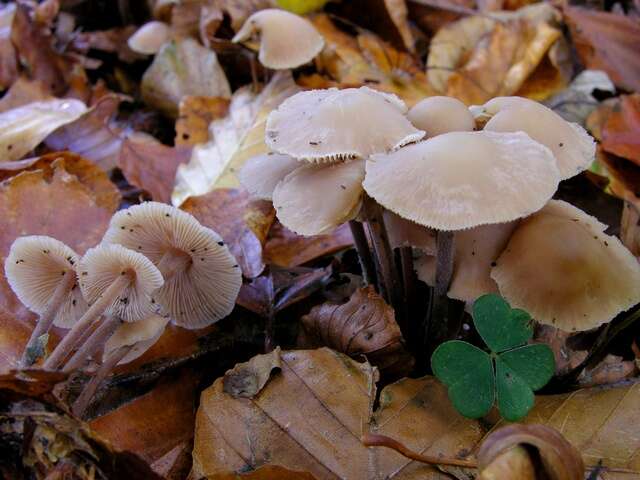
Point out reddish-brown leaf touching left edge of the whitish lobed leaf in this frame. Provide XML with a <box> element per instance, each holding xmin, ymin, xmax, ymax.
<box><xmin>117</xmin><ymin>134</ymin><xmax>191</xmax><ymax>203</ymax></box>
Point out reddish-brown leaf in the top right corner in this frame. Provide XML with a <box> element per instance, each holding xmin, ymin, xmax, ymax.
<box><xmin>562</xmin><ymin>6</ymin><xmax>640</xmax><ymax>91</ymax></box>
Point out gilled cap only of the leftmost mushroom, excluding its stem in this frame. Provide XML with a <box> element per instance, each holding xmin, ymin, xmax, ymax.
<box><xmin>4</xmin><ymin>235</ymin><xmax>87</xmax><ymax>328</ymax></box>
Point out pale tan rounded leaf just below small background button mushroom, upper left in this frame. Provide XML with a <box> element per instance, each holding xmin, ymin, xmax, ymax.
<box><xmin>140</xmin><ymin>38</ymin><xmax>231</xmax><ymax>117</ymax></box>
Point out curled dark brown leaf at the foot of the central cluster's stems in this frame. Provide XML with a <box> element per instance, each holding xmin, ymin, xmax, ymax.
<box><xmin>298</xmin><ymin>285</ymin><xmax>414</xmax><ymax>378</ymax></box>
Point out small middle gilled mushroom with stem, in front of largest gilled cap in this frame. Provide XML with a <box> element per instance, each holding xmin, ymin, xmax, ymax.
<box><xmin>44</xmin><ymin>244</ymin><xmax>163</xmax><ymax>369</ymax></box>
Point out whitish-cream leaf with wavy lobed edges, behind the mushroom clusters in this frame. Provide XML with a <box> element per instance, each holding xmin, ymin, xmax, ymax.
<box><xmin>171</xmin><ymin>71</ymin><xmax>299</xmax><ymax>205</ymax></box>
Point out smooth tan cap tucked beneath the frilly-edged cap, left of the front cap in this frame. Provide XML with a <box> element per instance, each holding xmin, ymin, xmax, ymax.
<box><xmin>273</xmin><ymin>160</ymin><xmax>364</xmax><ymax>235</ymax></box>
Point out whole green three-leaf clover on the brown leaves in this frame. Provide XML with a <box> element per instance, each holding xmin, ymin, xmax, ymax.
<box><xmin>431</xmin><ymin>294</ymin><xmax>555</xmax><ymax>421</ymax></box>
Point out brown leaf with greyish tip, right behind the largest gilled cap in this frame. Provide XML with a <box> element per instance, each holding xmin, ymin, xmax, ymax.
<box><xmin>181</xmin><ymin>188</ymin><xmax>275</xmax><ymax>278</ymax></box>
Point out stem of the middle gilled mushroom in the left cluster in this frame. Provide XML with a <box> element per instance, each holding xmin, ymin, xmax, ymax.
<box><xmin>43</xmin><ymin>270</ymin><xmax>135</xmax><ymax>370</ymax></box>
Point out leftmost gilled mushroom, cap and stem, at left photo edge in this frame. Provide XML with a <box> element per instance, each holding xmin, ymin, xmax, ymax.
<box><xmin>4</xmin><ymin>235</ymin><xmax>87</xmax><ymax>367</ymax></box>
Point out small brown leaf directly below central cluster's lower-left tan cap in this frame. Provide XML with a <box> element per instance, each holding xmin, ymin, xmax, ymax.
<box><xmin>263</xmin><ymin>221</ymin><xmax>353</xmax><ymax>268</ymax></box>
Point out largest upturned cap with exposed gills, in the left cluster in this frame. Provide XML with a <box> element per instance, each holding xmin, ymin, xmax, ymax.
<box><xmin>104</xmin><ymin>202</ymin><xmax>242</xmax><ymax>329</ymax></box>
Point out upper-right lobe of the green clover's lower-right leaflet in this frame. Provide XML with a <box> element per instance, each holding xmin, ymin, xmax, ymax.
<box><xmin>499</xmin><ymin>343</ymin><xmax>556</xmax><ymax>390</ymax></box>
